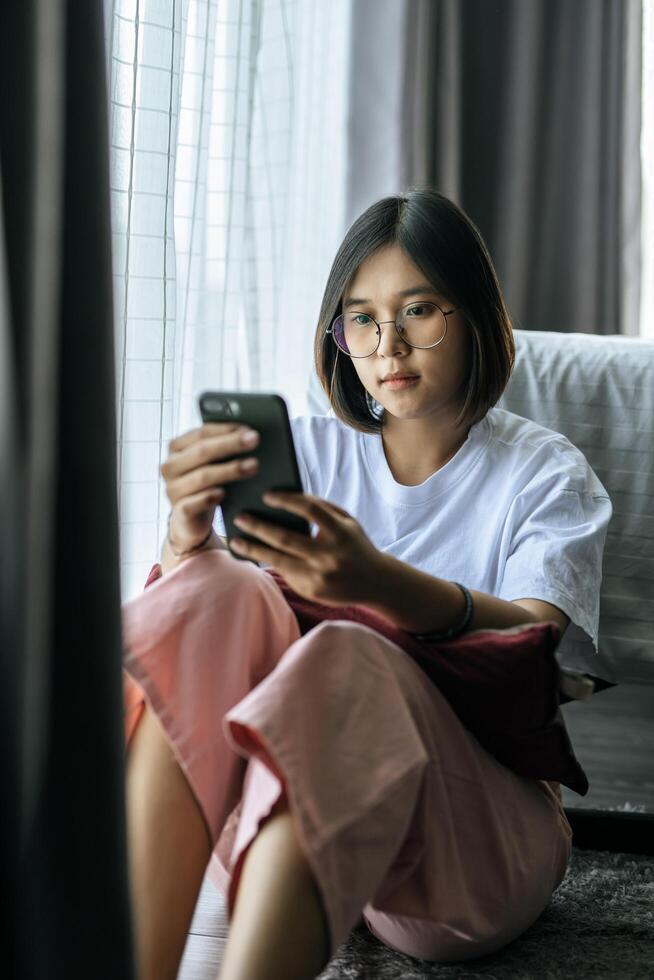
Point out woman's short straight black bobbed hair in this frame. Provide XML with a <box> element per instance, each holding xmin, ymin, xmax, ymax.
<box><xmin>314</xmin><ymin>187</ymin><xmax>515</xmax><ymax>432</ymax></box>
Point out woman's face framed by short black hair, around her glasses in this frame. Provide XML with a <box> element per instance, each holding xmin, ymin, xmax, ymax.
<box><xmin>343</xmin><ymin>245</ymin><xmax>470</xmax><ymax>424</ymax></box>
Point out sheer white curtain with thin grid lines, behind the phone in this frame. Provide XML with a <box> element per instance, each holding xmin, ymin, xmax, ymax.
<box><xmin>105</xmin><ymin>0</ymin><xmax>350</xmax><ymax>599</ymax></box>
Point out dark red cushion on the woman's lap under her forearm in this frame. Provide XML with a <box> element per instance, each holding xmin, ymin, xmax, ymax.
<box><xmin>146</xmin><ymin>565</ymin><xmax>588</xmax><ymax>796</ymax></box>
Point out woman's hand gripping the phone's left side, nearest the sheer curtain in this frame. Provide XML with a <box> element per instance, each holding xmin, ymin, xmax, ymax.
<box><xmin>160</xmin><ymin>422</ymin><xmax>259</xmax><ymax>551</ymax></box>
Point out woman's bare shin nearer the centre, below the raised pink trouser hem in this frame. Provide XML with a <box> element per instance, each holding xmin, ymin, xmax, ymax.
<box><xmin>219</xmin><ymin>806</ymin><xmax>330</xmax><ymax>980</ymax></box>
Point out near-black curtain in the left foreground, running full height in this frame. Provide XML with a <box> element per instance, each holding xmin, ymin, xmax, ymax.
<box><xmin>0</xmin><ymin>0</ymin><xmax>134</xmax><ymax>980</ymax></box>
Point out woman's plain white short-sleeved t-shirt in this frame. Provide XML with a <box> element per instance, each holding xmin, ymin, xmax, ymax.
<box><xmin>291</xmin><ymin>408</ymin><xmax>613</xmax><ymax>669</ymax></box>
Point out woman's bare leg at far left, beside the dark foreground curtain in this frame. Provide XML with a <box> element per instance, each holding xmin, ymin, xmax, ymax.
<box><xmin>126</xmin><ymin>705</ymin><xmax>212</xmax><ymax>980</ymax></box>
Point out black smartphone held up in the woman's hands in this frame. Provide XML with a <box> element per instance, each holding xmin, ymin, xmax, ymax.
<box><xmin>198</xmin><ymin>391</ymin><xmax>311</xmax><ymax>561</ymax></box>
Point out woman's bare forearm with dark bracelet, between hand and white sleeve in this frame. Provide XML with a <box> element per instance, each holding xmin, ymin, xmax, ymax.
<box><xmin>361</xmin><ymin>554</ymin><xmax>569</xmax><ymax>633</ymax></box>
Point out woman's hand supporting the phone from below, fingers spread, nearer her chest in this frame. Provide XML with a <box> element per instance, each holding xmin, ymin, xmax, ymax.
<box><xmin>230</xmin><ymin>491</ymin><xmax>382</xmax><ymax>606</ymax></box>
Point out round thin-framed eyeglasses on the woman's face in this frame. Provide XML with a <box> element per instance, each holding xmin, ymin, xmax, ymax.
<box><xmin>325</xmin><ymin>303</ymin><xmax>458</xmax><ymax>357</ymax></box>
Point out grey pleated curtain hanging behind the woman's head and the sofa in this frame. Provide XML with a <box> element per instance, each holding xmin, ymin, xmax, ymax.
<box><xmin>348</xmin><ymin>0</ymin><xmax>642</xmax><ymax>335</ymax></box>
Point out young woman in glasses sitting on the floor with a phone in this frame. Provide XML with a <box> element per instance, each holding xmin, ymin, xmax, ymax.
<box><xmin>123</xmin><ymin>189</ymin><xmax>611</xmax><ymax>980</ymax></box>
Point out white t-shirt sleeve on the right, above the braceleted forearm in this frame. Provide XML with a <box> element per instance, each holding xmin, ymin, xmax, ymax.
<box><xmin>499</xmin><ymin>476</ymin><xmax>613</xmax><ymax>656</ymax></box>
